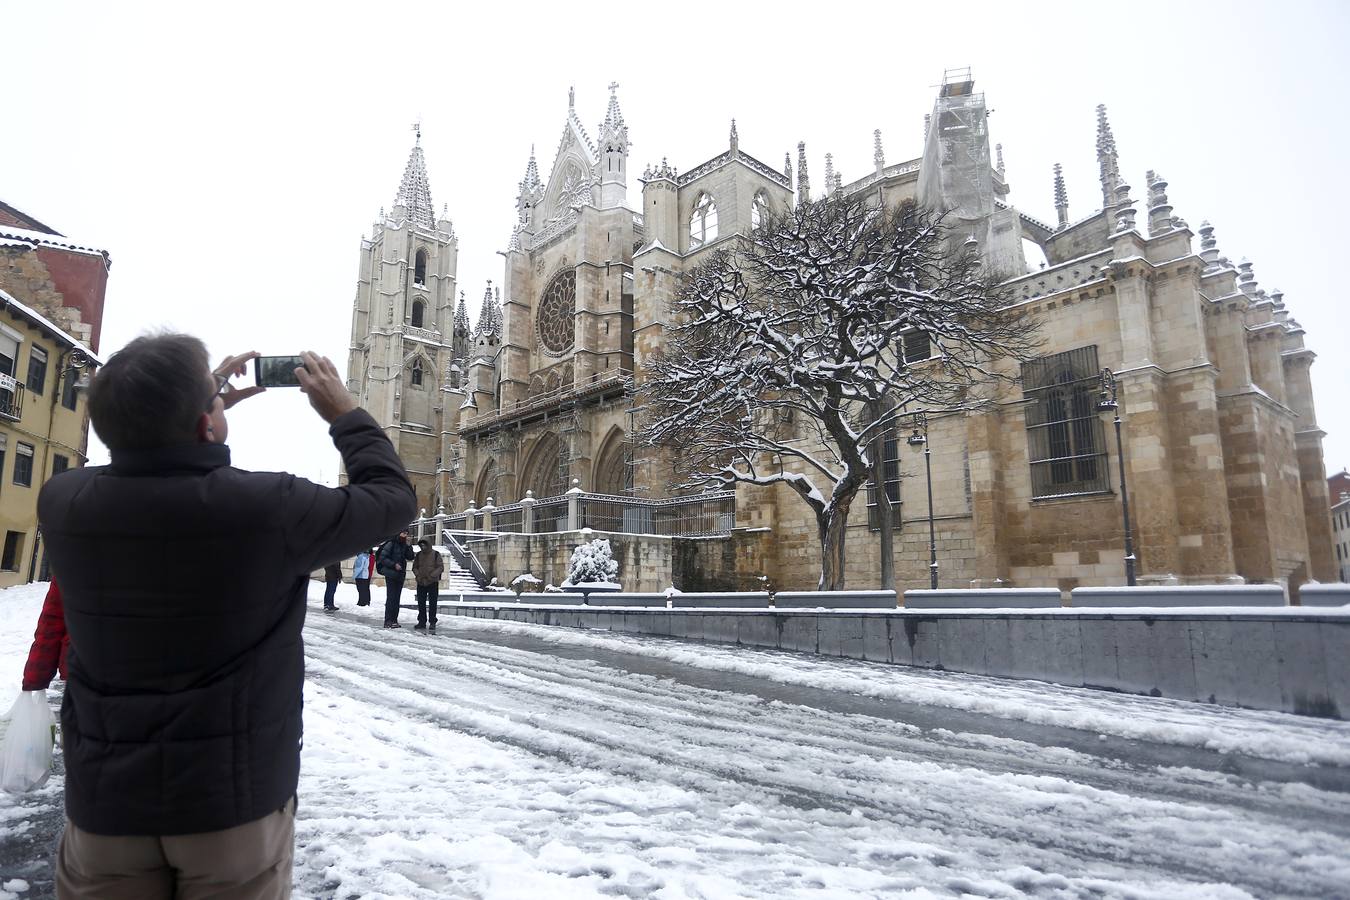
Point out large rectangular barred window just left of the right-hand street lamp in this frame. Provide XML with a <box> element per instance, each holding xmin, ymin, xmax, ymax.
<box><xmin>1022</xmin><ymin>347</ymin><xmax>1111</xmax><ymax>499</ymax></box>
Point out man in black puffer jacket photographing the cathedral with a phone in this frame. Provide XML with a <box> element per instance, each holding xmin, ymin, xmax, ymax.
<box><xmin>38</xmin><ymin>335</ymin><xmax>417</xmax><ymax>899</ymax></box>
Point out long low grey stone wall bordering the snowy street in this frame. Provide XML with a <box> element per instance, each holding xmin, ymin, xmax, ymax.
<box><xmin>441</xmin><ymin>600</ymin><xmax>1350</xmax><ymax>719</ymax></box>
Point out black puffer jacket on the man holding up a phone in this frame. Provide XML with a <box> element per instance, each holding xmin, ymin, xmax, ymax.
<box><xmin>38</xmin><ymin>410</ymin><xmax>417</xmax><ymax>835</ymax></box>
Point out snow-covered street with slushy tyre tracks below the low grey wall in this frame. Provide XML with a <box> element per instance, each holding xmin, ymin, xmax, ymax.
<box><xmin>0</xmin><ymin>584</ymin><xmax>1350</xmax><ymax>900</ymax></box>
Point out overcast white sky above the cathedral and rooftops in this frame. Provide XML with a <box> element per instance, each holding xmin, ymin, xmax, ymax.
<box><xmin>0</xmin><ymin>0</ymin><xmax>1350</xmax><ymax>493</ymax></box>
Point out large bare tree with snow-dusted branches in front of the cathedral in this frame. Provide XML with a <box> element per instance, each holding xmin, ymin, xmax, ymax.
<box><xmin>641</xmin><ymin>198</ymin><xmax>1035</xmax><ymax>590</ymax></box>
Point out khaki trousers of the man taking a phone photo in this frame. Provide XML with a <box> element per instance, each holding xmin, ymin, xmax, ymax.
<box><xmin>57</xmin><ymin>800</ymin><xmax>296</xmax><ymax>900</ymax></box>
